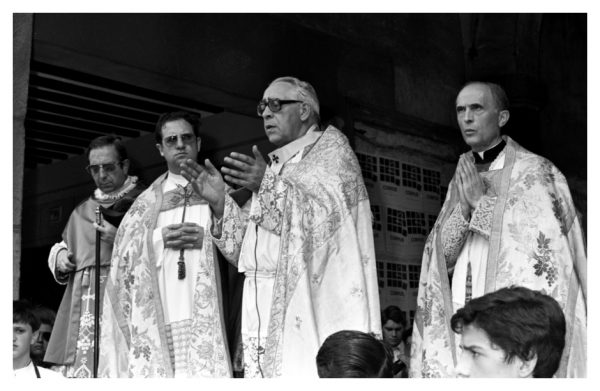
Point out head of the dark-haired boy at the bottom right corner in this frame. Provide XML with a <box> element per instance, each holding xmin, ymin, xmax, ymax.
<box><xmin>450</xmin><ymin>286</ymin><xmax>566</xmax><ymax>377</ymax></box>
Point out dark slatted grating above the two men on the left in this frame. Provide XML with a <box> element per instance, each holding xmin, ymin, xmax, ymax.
<box><xmin>25</xmin><ymin>61</ymin><xmax>223</xmax><ymax>168</ymax></box>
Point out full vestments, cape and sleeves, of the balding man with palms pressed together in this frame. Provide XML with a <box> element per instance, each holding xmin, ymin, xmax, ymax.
<box><xmin>410</xmin><ymin>136</ymin><xmax>587</xmax><ymax>377</ymax></box>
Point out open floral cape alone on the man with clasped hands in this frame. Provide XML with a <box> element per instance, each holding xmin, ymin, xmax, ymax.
<box><xmin>99</xmin><ymin>175</ymin><xmax>231</xmax><ymax>377</ymax></box>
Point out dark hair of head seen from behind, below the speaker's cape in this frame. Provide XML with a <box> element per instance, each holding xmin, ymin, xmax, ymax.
<box><xmin>317</xmin><ymin>330</ymin><xmax>393</xmax><ymax>377</ymax></box>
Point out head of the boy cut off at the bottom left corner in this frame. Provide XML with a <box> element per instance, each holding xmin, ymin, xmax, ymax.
<box><xmin>13</xmin><ymin>300</ymin><xmax>40</xmax><ymax>361</ymax></box>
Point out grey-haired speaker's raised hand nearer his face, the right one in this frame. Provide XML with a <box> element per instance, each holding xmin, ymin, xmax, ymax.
<box><xmin>221</xmin><ymin>145</ymin><xmax>267</xmax><ymax>192</ymax></box>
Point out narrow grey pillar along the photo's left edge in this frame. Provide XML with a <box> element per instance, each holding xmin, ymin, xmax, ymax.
<box><xmin>13</xmin><ymin>14</ymin><xmax>33</xmax><ymax>299</ymax></box>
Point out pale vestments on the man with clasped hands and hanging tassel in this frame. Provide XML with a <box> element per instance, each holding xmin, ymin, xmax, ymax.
<box><xmin>99</xmin><ymin>173</ymin><xmax>231</xmax><ymax>377</ymax></box>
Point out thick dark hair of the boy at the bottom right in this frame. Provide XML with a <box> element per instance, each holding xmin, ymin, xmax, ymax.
<box><xmin>450</xmin><ymin>286</ymin><xmax>566</xmax><ymax>377</ymax></box>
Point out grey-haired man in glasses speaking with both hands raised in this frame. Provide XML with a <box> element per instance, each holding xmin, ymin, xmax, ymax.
<box><xmin>184</xmin><ymin>77</ymin><xmax>381</xmax><ymax>378</ymax></box>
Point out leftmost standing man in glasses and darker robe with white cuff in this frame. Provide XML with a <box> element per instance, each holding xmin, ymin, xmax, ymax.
<box><xmin>44</xmin><ymin>135</ymin><xmax>143</xmax><ymax>377</ymax></box>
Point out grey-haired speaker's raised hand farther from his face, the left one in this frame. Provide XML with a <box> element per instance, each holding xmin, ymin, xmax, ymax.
<box><xmin>181</xmin><ymin>159</ymin><xmax>225</xmax><ymax>219</ymax></box>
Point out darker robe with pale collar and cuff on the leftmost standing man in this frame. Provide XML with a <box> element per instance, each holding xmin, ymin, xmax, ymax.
<box><xmin>44</xmin><ymin>176</ymin><xmax>144</xmax><ymax>377</ymax></box>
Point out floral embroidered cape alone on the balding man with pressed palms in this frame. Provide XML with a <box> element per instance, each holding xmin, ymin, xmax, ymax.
<box><xmin>410</xmin><ymin>138</ymin><xmax>587</xmax><ymax>377</ymax></box>
